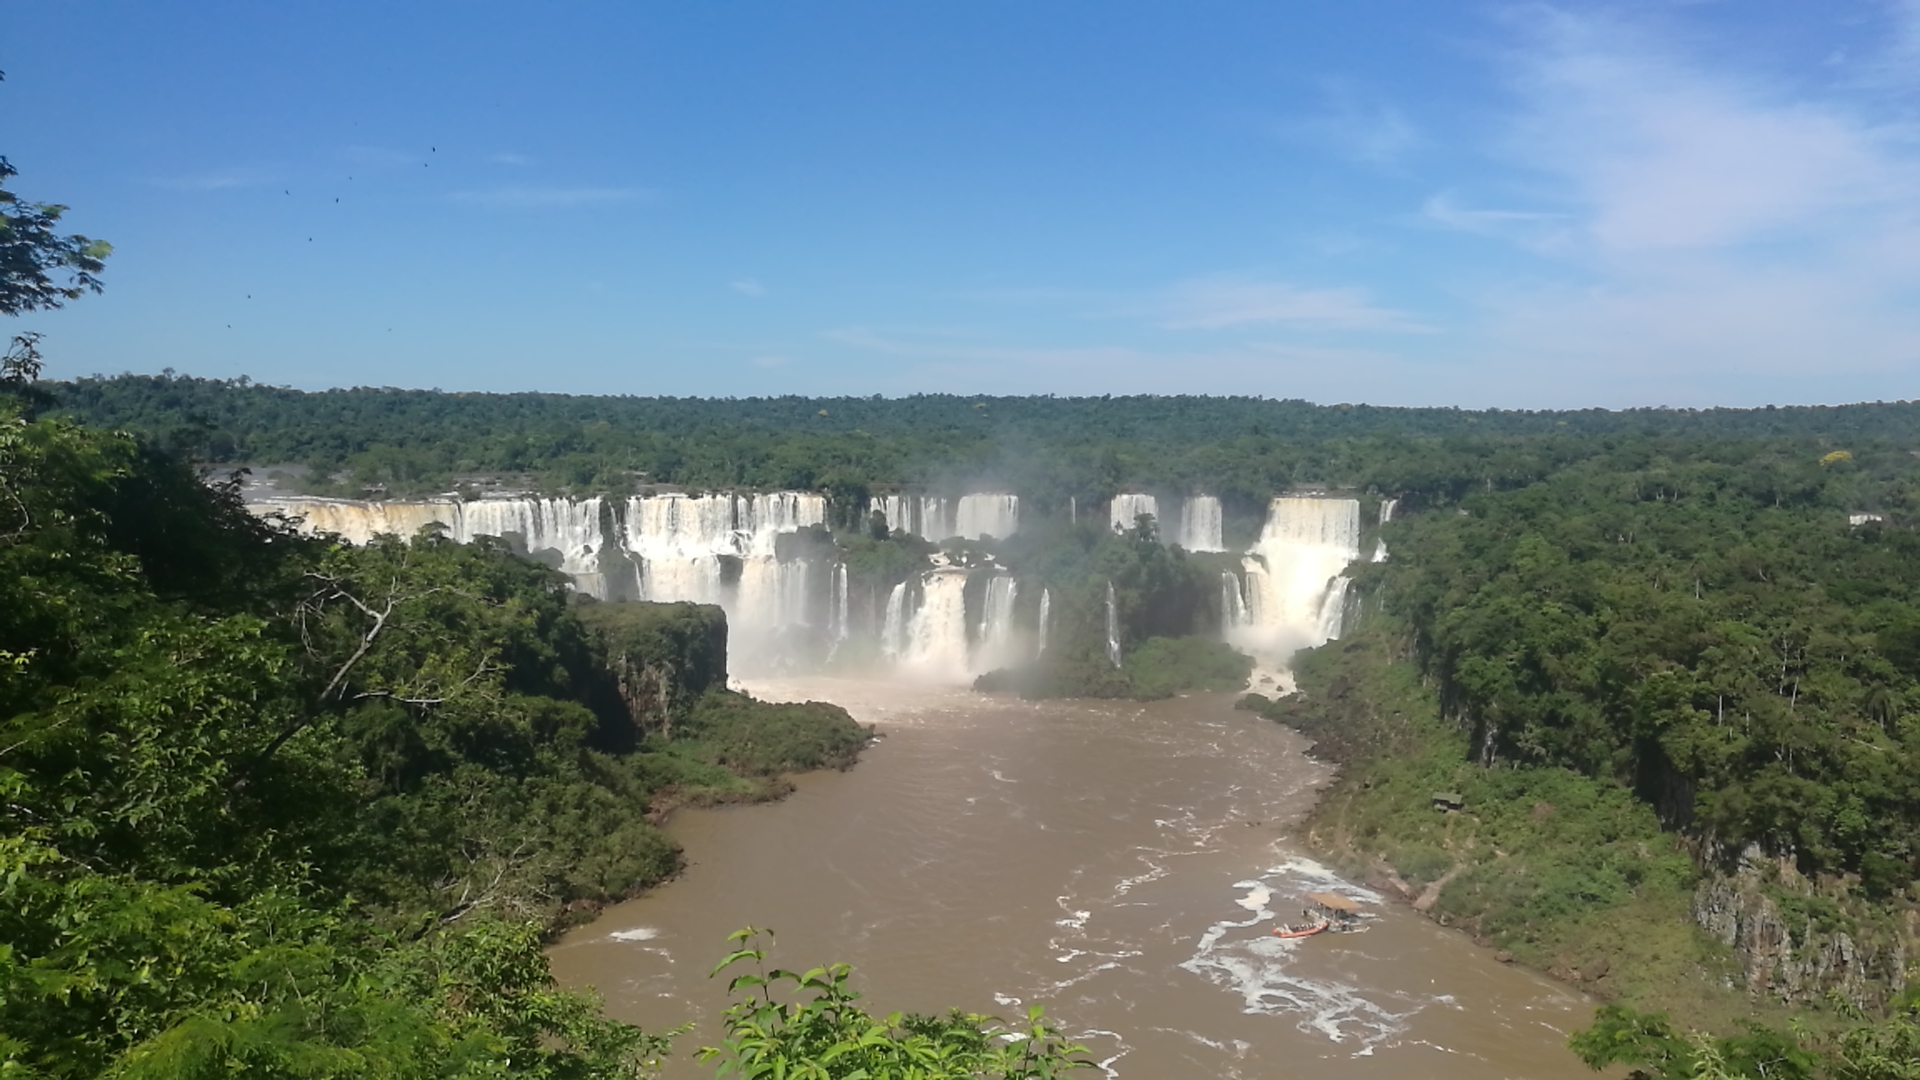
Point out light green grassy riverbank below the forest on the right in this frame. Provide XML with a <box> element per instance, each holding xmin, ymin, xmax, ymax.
<box><xmin>1244</xmin><ymin>619</ymin><xmax>1786</xmax><ymax>1030</ymax></box>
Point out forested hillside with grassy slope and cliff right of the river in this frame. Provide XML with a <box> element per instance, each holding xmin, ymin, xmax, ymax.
<box><xmin>1252</xmin><ymin>434</ymin><xmax>1920</xmax><ymax>1078</ymax></box>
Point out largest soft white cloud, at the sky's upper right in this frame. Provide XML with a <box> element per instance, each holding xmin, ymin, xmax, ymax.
<box><xmin>1511</xmin><ymin>10</ymin><xmax>1920</xmax><ymax>254</ymax></box>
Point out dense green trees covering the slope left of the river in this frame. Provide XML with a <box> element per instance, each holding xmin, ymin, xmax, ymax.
<box><xmin>0</xmin><ymin>396</ymin><xmax>864</xmax><ymax>1078</ymax></box>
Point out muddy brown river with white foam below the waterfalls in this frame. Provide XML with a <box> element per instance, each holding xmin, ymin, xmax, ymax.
<box><xmin>551</xmin><ymin>678</ymin><xmax>1592</xmax><ymax>1080</ymax></box>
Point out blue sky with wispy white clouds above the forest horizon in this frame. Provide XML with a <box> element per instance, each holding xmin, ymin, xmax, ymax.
<box><xmin>0</xmin><ymin>0</ymin><xmax>1920</xmax><ymax>407</ymax></box>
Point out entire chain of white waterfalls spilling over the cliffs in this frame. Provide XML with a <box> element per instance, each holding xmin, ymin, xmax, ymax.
<box><xmin>252</xmin><ymin>484</ymin><xmax>1367</xmax><ymax>678</ymax></box>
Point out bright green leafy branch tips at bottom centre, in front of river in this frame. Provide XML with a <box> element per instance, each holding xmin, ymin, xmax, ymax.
<box><xmin>701</xmin><ymin>926</ymin><xmax>1098</xmax><ymax>1080</ymax></box>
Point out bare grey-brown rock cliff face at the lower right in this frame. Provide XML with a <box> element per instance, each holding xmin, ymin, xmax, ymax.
<box><xmin>1693</xmin><ymin>851</ymin><xmax>1907</xmax><ymax>1009</ymax></box>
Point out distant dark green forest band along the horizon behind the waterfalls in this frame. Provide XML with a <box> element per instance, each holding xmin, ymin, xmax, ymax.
<box><xmin>44</xmin><ymin>375</ymin><xmax>1920</xmax><ymax>513</ymax></box>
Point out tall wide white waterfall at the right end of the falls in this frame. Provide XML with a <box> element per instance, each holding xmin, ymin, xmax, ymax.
<box><xmin>1233</xmin><ymin>498</ymin><xmax>1359</xmax><ymax>659</ymax></box>
